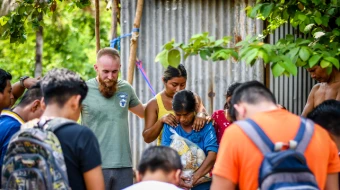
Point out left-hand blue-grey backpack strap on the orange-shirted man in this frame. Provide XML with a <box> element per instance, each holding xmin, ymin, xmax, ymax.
<box><xmin>235</xmin><ymin>119</ymin><xmax>275</xmax><ymax>155</ymax></box>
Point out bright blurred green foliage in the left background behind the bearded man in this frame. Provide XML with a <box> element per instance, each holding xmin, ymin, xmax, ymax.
<box><xmin>0</xmin><ymin>2</ymin><xmax>111</xmax><ymax>81</ymax></box>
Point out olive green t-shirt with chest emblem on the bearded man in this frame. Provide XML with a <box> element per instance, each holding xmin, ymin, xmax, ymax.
<box><xmin>81</xmin><ymin>78</ymin><xmax>140</xmax><ymax>168</ymax></box>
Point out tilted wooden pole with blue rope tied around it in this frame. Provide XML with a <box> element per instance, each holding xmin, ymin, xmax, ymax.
<box><xmin>127</xmin><ymin>0</ymin><xmax>144</xmax><ymax>85</ymax></box>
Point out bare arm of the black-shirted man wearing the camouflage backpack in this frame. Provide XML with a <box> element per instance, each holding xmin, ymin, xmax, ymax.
<box><xmin>83</xmin><ymin>166</ymin><xmax>105</xmax><ymax>190</ymax></box>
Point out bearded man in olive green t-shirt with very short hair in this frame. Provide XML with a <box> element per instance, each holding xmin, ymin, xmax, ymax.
<box><xmin>81</xmin><ymin>48</ymin><xmax>144</xmax><ymax>190</ymax></box>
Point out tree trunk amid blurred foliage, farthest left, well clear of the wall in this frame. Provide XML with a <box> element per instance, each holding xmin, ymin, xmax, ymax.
<box><xmin>34</xmin><ymin>13</ymin><xmax>44</xmax><ymax>77</ymax></box>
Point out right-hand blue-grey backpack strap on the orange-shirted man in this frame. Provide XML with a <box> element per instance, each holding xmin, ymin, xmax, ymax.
<box><xmin>294</xmin><ymin>117</ymin><xmax>314</xmax><ymax>154</ymax></box>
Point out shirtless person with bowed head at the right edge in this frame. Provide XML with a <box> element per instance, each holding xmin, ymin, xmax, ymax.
<box><xmin>302</xmin><ymin>65</ymin><xmax>340</xmax><ymax>117</ymax></box>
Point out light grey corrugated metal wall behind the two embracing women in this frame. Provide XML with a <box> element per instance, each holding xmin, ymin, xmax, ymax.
<box><xmin>121</xmin><ymin>0</ymin><xmax>264</xmax><ymax>166</ymax></box>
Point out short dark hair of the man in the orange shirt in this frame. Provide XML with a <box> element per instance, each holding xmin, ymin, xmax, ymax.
<box><xmin>228</xmin><ymin>81</ymin><xmax>276</xmax><ymax>121</ymax></box>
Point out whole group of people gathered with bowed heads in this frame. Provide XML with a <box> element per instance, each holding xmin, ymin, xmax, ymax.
<box><xmin>0</xmin><ymin>48</ymin><xmax>340</xmax><ymax>190</ymax></box>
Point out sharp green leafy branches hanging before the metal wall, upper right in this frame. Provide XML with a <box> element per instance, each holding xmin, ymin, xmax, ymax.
<box><xmin>155</xmin><ymin>0</ymin><xmax>340</xmax><ymax>76</ymax></box>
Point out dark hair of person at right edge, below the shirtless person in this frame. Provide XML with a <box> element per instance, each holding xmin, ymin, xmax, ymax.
<box><xmin>307</xmin><ymin>100</ymin><xmax>340</xmax><ymax>137</ymax></box>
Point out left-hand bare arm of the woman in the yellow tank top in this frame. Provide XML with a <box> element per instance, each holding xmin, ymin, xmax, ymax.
<box><xmin>143</xmin><ymin>99</ymin><xmax>177</xmax><ymax>143</ymax></box>
